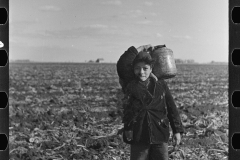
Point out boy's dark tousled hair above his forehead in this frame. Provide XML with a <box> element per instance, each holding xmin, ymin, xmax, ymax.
<box><xmin>132</xmin><ymin>52</ymin><xmax>155</xmax><ymax>68</ymax></box>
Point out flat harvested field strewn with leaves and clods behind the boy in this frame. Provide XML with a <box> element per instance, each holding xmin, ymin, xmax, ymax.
<box><xmin>9</xmin><ymin>63</ymin><xmax>228</xmax><ymax>160</ymax></box>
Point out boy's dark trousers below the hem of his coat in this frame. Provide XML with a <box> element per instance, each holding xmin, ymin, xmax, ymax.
<box><xmin>130</xmin><ymin>143</ymin><xmax>168</xmax><ymax>160</ymax></box>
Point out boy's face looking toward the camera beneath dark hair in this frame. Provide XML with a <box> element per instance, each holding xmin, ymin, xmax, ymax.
<box><xmin>134</xmin><ymin>62</ymin><xmax>152</xmax><ymax>81</ymax></box>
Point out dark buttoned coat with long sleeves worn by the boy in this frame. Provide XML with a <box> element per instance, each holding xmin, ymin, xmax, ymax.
<box><xmin>123</xmin><ymin>77</ymin><xmax>184</xmax><ymax>144</ymax></box>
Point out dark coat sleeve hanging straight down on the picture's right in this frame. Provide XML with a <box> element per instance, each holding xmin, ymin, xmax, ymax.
<box><xmin>163</xmin><ymin>81</ymin><xmax>184</xmax><ymax>134</ymax></box>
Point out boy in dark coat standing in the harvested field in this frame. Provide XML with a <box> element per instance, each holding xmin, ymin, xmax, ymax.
<box><xmin>123</xmin><ymin>49</ymin><xmax>183</xmax><ymax>160</ymax></box>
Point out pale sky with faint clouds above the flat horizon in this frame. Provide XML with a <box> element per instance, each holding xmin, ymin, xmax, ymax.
<box><xmin>9</xmin><ymin>0</ymin><xmax>228</xmax><ymax>63</ymax></box>
